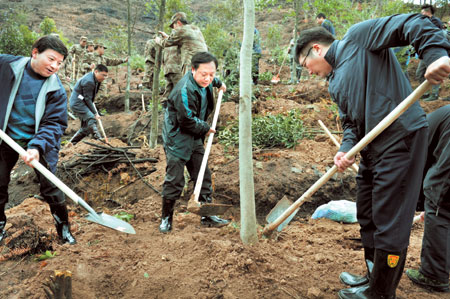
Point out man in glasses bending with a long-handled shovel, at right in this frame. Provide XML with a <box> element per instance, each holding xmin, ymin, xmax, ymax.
<box><xmin>296</xmin><ymin>14</ymin><xmax>450</xmax><ymax>298</ymax></box>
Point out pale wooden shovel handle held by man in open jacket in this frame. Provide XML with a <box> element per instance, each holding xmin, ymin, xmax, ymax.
<box><xmin>0</xmin><ymin>130</ymin><xmax>101</xmax><ymax>221</ymax></box>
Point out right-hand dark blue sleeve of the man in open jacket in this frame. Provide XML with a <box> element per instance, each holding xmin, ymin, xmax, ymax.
<box><xmin>28</xmin><ymin>87</ymin><xmax>67</xmax><ymax>155</ymax></box>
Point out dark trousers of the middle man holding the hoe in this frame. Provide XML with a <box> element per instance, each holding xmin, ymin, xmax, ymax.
<box><xmin>162</xmin><ymin>141</ymin><xmax>212</xmax><ymax>200</ymax></box>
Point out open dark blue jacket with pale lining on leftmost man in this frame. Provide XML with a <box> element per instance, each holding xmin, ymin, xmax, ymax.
<box><xmin>0</xmin><ymin>54</ymin><xmax>67</xmax><ymax>172</ymax></box>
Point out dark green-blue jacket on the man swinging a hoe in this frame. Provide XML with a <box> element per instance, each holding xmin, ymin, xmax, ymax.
<box><xmin>162</xmin><ymin>72</ymin><xmax>222</xmax><ymax>161</ymax></box>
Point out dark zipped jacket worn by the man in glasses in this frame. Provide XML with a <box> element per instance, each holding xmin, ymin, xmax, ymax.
<box><xmin>325</xmin><ymin>14</ymin><xmax>450</xmax><ymax>160</ymax></box>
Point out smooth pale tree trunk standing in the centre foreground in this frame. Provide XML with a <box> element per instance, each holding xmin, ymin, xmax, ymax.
<box><xmin>239</xmin><ymin>0</ymin><xmax>258</xmax><ymax>244</ymax></box>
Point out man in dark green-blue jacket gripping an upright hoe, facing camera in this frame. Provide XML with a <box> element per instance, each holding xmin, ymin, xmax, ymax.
<box><xmin>159</xmin><ymin>52</ymin><xmax>228</xmax><ymax>233</ymax></box>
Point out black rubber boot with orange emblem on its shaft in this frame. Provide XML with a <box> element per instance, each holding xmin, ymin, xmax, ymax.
<box><xmin>338</xmin><ymin>249</ymin><xmax>407</xmax><ymax>299</ymax></box>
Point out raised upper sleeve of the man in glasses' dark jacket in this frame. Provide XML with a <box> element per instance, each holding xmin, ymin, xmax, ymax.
<box><xmin>344</xmin><ymin>14</ymin><xmax>450</xmax><ymax>65</ymax></box>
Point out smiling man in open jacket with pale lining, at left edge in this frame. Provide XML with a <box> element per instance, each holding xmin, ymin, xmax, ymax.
<box><xmin>0</xmin><ymin>35</ymin><xmax>76</xmax><ymax>244</ymax></box>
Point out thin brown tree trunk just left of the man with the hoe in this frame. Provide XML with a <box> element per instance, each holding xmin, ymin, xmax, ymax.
<box><xmin>150</xmin><ymin>0</ymin><xmax>166</xmax><ymax>148</ymax></box>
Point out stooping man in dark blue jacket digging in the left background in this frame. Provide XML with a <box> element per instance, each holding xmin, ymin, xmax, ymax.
<box><xmin>70</xmin><ymin>64</ymin><xmax>108</xmax><ymax>145</ymax></box>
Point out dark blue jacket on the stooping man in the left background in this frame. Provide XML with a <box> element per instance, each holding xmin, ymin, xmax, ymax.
<box><xmin>70</xmin><ymin>72</ymin><xmax>100</xmax><ymax>115</ymax></box>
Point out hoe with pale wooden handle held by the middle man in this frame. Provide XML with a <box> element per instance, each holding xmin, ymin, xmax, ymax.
<box><xmin>187</xmin><ymin>90</ymin><xmax>232</xmax><ymax>216</ymax></box>
